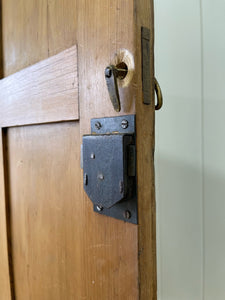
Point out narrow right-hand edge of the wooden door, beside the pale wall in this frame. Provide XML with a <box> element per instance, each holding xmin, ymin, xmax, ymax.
<box><xmin>134</xmin><ymin>0</ymin><xmax>157</xmax><ymax>300</ymax></box>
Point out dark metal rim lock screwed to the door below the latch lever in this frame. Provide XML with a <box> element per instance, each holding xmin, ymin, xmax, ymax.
<box><xmin>82</xmin><ymin>115</ymin><xmax>137</xmax><ymax>224</ymax></box>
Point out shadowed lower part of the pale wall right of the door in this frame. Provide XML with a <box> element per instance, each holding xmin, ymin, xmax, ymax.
<box><xmin>156</xmin><ymin>153</ymin><xmax>225</xmax><ymax>300</ymax></box>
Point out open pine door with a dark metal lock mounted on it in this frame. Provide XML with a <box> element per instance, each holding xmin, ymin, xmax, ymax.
<box><xmin>0</xmin><ymin>0</ymin><xmax>157</xmax><ymax>300</ymax></box>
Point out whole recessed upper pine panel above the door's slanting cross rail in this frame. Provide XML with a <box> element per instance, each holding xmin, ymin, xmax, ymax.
<box><xmin>1</xmin><ymin>0</ymin><xmax>78</xmax><ymax>76</ymax></box>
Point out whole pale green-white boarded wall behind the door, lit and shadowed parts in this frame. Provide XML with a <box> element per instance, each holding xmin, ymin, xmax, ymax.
<box><xmin>155</xmin><ymin>0</ymin><xmax>225</xmax><ymax>300</ymax></box>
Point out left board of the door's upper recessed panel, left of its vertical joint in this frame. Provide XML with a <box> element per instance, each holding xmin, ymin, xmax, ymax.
<box><xmin>1</xmin><ymin>0</ymin><xmax>48</xmax><ymax>76</ymax></box>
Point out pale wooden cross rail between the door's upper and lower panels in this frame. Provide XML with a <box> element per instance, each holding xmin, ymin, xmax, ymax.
<box><xmin>0</xmin><ymin>46</ymin><xmax>79</xmax><ymax>127</ymax></box>
